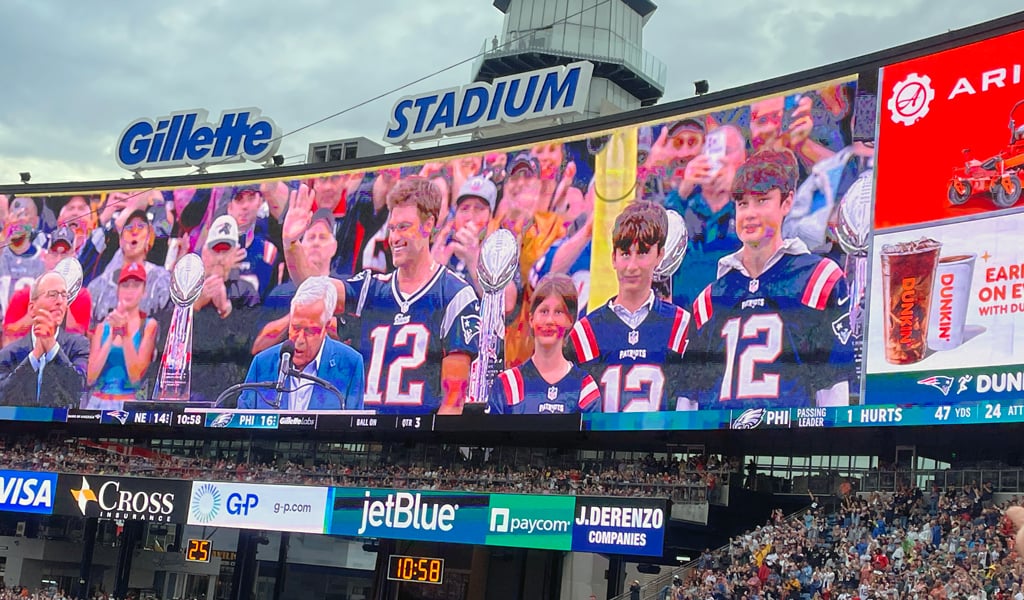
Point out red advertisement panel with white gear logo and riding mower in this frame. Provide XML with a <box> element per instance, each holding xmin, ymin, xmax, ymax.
<box><xmin>874</xmin><ymin>27</ymin><xmax>1024</xmax><ymax>228</ymax></box>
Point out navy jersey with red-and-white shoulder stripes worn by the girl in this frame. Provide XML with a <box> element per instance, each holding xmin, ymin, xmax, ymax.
<box><xmin>487</xmin><ymin>358</ymin><xmax>601</xmax><ymax>415</ymax></box>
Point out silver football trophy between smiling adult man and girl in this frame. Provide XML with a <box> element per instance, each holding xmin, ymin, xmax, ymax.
<box><xmin>466</xmin><ymin>229</ymin><xmax>519</xmax><ymax>405</ymax></box>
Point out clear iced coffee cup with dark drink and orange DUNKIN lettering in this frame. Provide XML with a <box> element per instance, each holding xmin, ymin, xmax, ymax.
<box><xmin>882</xmin><ymin>239</ymin><xmax>942</xmax><ymax>365</ymax></box>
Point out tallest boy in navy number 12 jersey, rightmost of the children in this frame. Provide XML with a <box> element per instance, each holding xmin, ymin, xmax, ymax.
<box><xmin>690</xmin><ymin>149</ymin><xmax>856</xmax><ymax>409</ymax></box>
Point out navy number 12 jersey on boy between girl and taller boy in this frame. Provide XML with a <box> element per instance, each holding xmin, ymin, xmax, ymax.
<box><xmin>569</xmin><ymin>298</ymin><xmax>690</xmax><ymax>413</ymax></box>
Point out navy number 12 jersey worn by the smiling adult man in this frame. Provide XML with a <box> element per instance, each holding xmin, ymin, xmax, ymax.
<box><xmin>345</xmin><ymin>266</ymin><xmax>480</xmax><ymax>415</ymax></box>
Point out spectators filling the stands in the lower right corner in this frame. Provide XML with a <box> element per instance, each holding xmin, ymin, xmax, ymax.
<box><xmin>659</xmin><ymin>481</ymin><xmax>1024</xmax><ymax>600</ymax></box>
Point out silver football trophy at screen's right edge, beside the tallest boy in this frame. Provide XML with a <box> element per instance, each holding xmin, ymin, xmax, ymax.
<box><xmin>836</xmin><ymin>169</ymin><xmax>874</xmax><ymax>363</ymax></box>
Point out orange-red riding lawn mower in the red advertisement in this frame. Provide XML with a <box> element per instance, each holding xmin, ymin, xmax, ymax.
<box><xmin>947</xmin><ymin>100</ymin><xmax>1024</xmax><ymax>208</ymax></box>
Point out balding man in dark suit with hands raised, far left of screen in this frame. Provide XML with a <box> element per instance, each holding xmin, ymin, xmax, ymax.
<box><xmin>0</xmin><ymin>271</ymin><xmax>89</xmax><ymax>408</ymax></box>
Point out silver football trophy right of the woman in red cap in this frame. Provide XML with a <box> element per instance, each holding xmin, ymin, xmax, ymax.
<box><xmin>154</xmin><ymin>254</ymin><xmax>206</xmax><ymax>401</ymax></box>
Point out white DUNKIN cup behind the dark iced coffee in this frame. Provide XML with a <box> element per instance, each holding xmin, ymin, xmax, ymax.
<box><xmin>928</xmin><ymin>254</ymin><xmax>976</xmax><ymax>350</ymax></box>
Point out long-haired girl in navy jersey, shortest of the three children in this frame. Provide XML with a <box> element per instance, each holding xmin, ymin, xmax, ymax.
<box><xmin>487</xmin><ymin>273</ymin><xmax>601</xmax><ymax>415</ymax></box>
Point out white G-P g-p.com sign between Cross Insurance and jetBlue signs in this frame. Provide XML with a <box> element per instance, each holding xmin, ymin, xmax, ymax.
<box><xmin>188</xmin><ymin>481</ymin><xmax>328</xmax><ymax>533</ymax></box>
